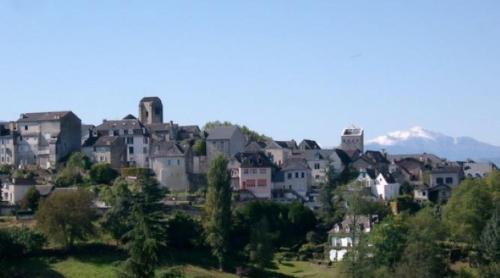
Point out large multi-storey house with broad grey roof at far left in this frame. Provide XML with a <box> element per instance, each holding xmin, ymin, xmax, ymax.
<box><xmin>16</xmin><ymin>111</ymin><xmax>82</xmax><ymax>169</ymax></box>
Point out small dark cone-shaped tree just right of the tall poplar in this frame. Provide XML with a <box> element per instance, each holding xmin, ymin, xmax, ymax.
<box><xmin>247</xmin><ymin>216</ymin><xmax>274</xmax><ymax>269</ymax></box>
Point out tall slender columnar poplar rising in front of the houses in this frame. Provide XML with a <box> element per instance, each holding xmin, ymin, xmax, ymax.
<box><xmin>204</xmin><ymin>155</ymin><xmax>231</xmax><ymax>270</ymax></box>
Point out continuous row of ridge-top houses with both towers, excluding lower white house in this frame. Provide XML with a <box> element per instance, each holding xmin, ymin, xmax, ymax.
<box><xmin>0</xmin><ymin>97</ymin><xmax>495</xmax><ymax>204</ymax></box>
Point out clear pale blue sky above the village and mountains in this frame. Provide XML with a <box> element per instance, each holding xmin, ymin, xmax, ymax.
<box><xmin>0</xmin><ymin>0</ymin><xmax>500</xmax><ymax>146</ymax></box>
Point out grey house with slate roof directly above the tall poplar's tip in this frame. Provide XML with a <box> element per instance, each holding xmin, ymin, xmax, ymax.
<box><xmin>207</xmin><ymin>126</ymin><xmax>247</xmax><ymax>161</ymax></box>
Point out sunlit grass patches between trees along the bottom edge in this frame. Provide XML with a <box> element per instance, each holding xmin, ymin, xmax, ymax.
<box><xmin>7</xmin><ymin>247</ymin><xmax>335</xmax><ymax>278</ymax></box>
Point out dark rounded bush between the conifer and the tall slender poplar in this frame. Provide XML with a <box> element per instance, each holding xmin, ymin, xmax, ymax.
<box><xmin>165</xmin><ymin>213</ymin><xmax>203</xmax><ymax>250</ymax></box>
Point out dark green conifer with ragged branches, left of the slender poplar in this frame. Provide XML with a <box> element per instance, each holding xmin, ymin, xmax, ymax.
<box><xmin>120</xmin><ymin>176</ymin><xmax>165</xmax><ymax>278</ymax></box>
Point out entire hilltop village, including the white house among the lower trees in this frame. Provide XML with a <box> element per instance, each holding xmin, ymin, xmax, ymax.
<box><xmin>0</xmin><ymin>97</ymin><xmax>498</xmax><ymax>274</ymax></box>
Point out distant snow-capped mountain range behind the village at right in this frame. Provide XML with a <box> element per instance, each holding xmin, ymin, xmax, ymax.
<box><xmin>365</xmin><ymin>127</ymin><xmax>500</xmax><ymax>165</ymax></box>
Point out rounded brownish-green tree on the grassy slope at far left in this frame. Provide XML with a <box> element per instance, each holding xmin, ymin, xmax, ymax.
<box><xmin>35</xmin><ymin>189</ymin><xmax>95</xmax><ymax>249</ymax></box>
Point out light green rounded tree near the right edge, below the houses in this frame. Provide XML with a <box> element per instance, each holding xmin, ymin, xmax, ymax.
<box><xmin>443</xmin><ymin>179</ymin><xmax>494</xmax><ymax>243</ymax></box>
